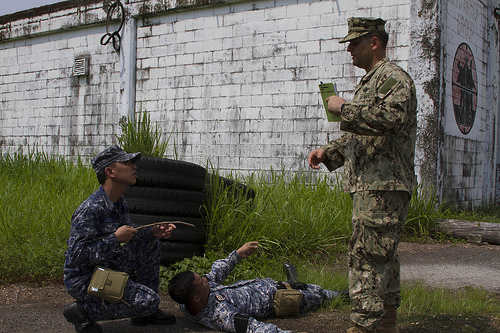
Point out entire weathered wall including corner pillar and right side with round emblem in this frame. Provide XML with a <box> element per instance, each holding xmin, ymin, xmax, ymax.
<box><xmin>0</xmin><ymin>0</ymin><xmax>498</xmax><ymax>206</ymax></box>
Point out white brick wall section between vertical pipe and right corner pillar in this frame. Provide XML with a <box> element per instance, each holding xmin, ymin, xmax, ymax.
<box><xmin>136</xmin><ymin>0</ymin><xmax>410</xmax><ymax>172</ymax></box>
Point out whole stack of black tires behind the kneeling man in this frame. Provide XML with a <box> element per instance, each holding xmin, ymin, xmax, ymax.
<box><xmin>124</xmin><ymin>156</ymin><xmax>207</xmax><ymax>266</ymax></box>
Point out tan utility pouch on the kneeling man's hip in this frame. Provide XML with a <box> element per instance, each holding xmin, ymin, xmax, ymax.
<box><xmin>87</xmin><ymin>267</ymin><xmax>128</xmax><ymax>303</ymax></box>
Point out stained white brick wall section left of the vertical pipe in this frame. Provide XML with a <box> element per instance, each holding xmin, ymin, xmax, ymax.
<box><xmin>0</xmin><ymin>0</ymin><xmax>119</xmax><ymax>156</ymax></box>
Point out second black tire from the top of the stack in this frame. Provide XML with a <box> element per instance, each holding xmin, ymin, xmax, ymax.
<box><xmin>124</xmin><ymin>186</ymin><xmax>207</xmax><ymax>216</ymax></box>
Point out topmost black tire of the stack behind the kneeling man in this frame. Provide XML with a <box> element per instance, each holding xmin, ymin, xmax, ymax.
<box><xmin>135</xmin><ymin>156</ymin><xmax>207</xmax><ymax>190</ymax></box>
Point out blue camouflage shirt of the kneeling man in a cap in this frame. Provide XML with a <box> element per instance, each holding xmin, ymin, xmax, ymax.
<box><xmin>64</xmin><ymin>186</ymin><xmax>157</xmax><ymax>300</ymax></box>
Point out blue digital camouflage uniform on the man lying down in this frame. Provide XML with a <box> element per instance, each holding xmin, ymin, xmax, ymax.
<box><xmin>179</xmin><ymin>251</ymin><xmax>338</xmax><ymax>333</ymax></box>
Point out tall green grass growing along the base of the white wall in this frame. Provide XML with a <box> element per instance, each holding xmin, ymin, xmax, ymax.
<box><xmin>0</xmin><ymin>152</ymin><xmax>476</xmax><ymax>282</ymax></box>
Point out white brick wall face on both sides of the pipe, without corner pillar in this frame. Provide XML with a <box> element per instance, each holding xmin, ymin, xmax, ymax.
<box><xmin>0</xmin><ymin>0</ymin><xmax>409</xmax><ymax>171</ymax></box>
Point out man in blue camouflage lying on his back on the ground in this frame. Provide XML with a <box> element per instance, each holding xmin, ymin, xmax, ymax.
<box><xmin>168</xmin><ymin>242</ymin><xmax>343</xmax><ymax>333</ymax></box>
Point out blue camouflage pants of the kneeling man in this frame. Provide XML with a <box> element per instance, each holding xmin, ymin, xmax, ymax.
<box><xmin>83</xmin><ymin>240</ymin><xmax>160</xmax><ymax>321</ymax></box>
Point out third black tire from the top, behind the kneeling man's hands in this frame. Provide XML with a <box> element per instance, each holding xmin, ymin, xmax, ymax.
<box><xmin>130</xmin><ymin>213</ymin><xmax>206</xmax><ymax>244</ymax></box>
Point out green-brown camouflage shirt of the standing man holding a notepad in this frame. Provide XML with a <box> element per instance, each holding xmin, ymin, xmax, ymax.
<box><xmin>322</xmin><ymin>58</ymin><xmax>417</xmax><ymax>193</ymax></box>
